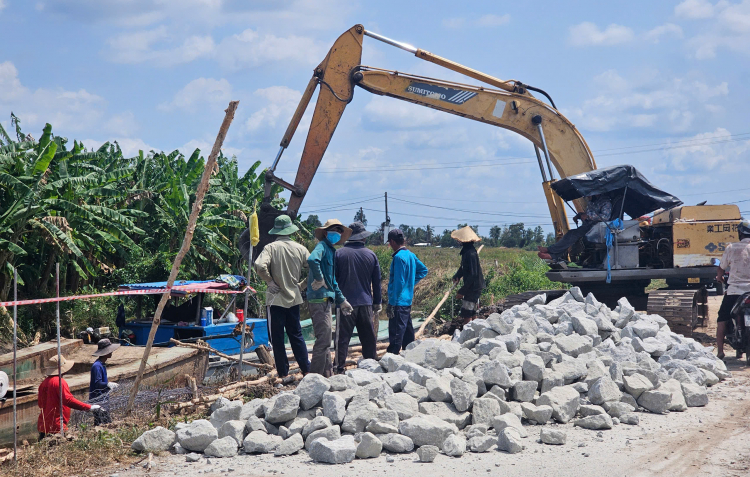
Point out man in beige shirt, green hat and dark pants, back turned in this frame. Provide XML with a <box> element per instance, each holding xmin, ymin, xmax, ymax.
<box><xmin>255</xmin><ymin>215</ymin><xmax>310</xmax><ymax>378</ymax></box>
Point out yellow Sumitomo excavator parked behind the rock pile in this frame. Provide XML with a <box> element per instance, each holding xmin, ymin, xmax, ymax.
<box><xmin>248</xmin><ymin>25</ymin><xmax>741</xmax><ymax>332</ymax></box>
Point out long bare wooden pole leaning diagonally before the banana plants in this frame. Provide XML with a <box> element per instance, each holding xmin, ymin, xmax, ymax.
<box><xmin>125</xmin><ymin>101</ymin><xmax>240</xmax><ymax>415</ymax></box>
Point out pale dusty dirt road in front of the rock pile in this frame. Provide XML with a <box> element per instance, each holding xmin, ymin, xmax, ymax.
<box><xmin>101</xmin><ymin>297</ymin><xmax>750</xmax><ymax>477</ymax></box>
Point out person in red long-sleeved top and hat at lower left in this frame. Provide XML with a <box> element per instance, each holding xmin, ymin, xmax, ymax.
<box><xmin>36</xmin><ymin>356</ymin><xmax>101</xmax><ymax>440</ymax></box>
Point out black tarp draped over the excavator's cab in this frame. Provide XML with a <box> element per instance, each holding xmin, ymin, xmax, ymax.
<box><xmin>552</xmin><ymin>166</ymin><xmax>682</xmax><ymax>218</ymax></box>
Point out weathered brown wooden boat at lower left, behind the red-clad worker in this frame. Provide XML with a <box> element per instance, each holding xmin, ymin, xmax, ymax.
<box><xmin>0</xmin><ymin>338</ymin><xmax>208</xmax><ymax>447</ymax></box>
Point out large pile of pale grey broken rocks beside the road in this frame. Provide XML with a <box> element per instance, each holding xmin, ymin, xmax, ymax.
<box><xmin>133</xmin><ymin>288</ymin><xmax>730</xmax><ymax>464</ymax></box>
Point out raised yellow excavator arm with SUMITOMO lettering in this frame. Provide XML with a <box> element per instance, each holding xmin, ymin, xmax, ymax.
<box><xmin>257</xmin><ymin>25</ymin><xmax>596</xmax><ymax>253</ymax></box>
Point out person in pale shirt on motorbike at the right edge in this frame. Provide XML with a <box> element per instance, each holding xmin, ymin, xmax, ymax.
<box><xmin>716</xmin><ymin>221</ymin><xmax>750</xmax><ymax>359</ymax></box>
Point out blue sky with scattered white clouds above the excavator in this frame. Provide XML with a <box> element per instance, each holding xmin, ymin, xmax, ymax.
<box><xmin>0</xmin><ymin>0</ymin><xmax>750</xmax><ymax>234</ymax></box>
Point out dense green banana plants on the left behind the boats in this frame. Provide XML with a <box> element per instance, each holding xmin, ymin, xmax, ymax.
<box><xmin>0</xmin><ymin>115</ymin><xmax>296</xmax><ymax>343</ymax></box>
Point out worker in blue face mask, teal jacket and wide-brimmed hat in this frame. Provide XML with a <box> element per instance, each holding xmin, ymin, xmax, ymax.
<box><xmin>307</xmin><ymin>219</ymin><xmax>353</xmax><ymax>377</ymax></box>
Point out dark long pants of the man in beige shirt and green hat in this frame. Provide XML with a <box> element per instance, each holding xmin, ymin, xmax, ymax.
<box><xmin>271</xmin><ymin>305</ymin><xmax>310</xmax><ymax>378</ymax></box>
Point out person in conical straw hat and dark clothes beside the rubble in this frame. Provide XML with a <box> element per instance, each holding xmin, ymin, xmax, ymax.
<box><xmin>448</xmin><ymin>225</ymin><xmax>485</xmax><ymax>334</ymax></box>
